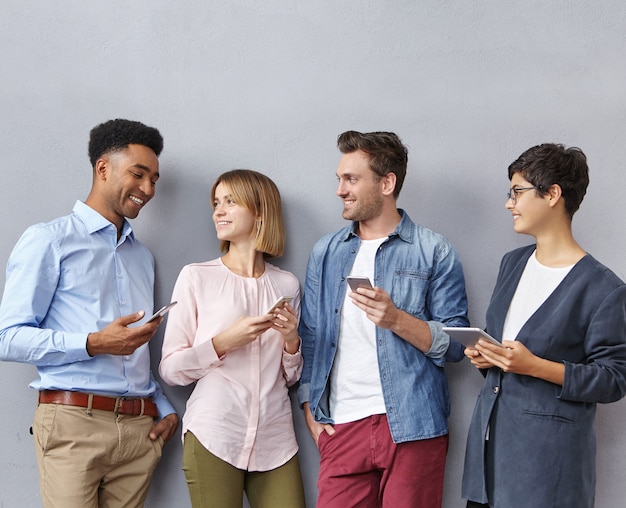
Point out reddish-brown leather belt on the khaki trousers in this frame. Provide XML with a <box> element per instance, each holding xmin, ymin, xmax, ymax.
<box><xmin>39</xmin><ymin>390</ymin><xmax>159</xmax><ymax>418</ymax></box>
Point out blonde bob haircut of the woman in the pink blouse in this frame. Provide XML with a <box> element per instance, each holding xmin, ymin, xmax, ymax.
<box><xmin>211</xmin><ymin>169</ymin><xmax>285</xmax><ymax>257</ymax></box>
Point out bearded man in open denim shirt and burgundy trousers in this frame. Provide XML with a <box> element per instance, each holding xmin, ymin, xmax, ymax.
<box><xmin>298</xmin><ymin>131</ymin><xmax>468</xmax><ymax>508</ymax></box>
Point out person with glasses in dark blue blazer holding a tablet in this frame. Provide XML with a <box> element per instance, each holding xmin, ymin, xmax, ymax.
<box><xmin>462</xmin><ymin>144</ymin><xmax>626</xmax><ymax>508</ymax></box>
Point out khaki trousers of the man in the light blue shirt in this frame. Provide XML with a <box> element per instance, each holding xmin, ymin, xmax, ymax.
<box><xmin>33</xmin><ymin>404</ymin><xmax>163</xmax><ymax>508</ymax></box>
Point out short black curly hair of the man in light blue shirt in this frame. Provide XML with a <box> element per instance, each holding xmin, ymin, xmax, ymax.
<box><xmin>89</xmin><ymin>118</ymin><xmax>163</xmax><ymax>167</ymax></box>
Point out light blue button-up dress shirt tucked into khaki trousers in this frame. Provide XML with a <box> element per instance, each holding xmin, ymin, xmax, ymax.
<box><xmin>0</xmin><ymin>201</ymin><xmax>175</xmax><ymax>418</ymax></box>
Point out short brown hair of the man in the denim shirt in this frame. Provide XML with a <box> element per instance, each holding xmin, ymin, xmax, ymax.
<box><xmin>337</xmin><ymin>131</ymin><xmax>409</xmax><ymax>199</ymax></box>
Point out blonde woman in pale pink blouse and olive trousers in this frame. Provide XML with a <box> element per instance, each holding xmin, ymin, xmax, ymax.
<box><xmin>159</xmin><ymin>169</ymin><xmax>305</xmax><ymax>508</ymax></box>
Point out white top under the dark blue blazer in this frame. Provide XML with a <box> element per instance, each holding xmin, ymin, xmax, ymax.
<box><xmin>502</xmin><ymin>251</ymin><xmax>574</xmax><ymax>340</ymax></box>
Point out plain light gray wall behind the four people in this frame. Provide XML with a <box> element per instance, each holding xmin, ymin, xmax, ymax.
<box><xmin>0</xmin><ymin>0</ymin><xmax>626</xmax><ymax>508</ymax></box>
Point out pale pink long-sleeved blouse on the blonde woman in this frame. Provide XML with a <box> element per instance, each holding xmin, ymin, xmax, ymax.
<box><xmin>159</xmin><ymin>259</ymin><xmax>302</xmax><ymax>471</ymax></box>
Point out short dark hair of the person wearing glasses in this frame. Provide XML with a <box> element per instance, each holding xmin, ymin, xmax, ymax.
<box><xmin>509</xmin><ymin>143</ymin><xmax>589</xmax><ymax>217</ymax></box>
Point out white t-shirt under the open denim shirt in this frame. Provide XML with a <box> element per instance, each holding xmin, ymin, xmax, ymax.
<box><xmin>330</xmin><ymin>237</ymin><xmax>387</xmax><ymax>423</ymax></box>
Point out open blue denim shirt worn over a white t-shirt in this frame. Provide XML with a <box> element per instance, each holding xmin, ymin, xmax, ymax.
<box><xmin>298</xmin><ymin>210</ymin><xmax>469</xmax><ymax>443</ymax></box>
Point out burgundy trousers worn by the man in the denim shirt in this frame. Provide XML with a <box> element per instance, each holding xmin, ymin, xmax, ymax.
<box><xmin>317</xmin><ymin>414</ymin><xmax>448</xmax><ymax>508</ymax></box>
